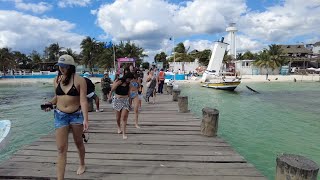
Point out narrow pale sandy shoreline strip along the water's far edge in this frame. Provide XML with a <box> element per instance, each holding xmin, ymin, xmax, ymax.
<box><xmin>0</xmin><ymin>74</ymin><xmax>320</xmax><ymax>84</ymax></box>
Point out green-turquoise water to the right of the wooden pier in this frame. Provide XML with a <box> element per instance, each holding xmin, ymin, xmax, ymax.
<box><xmin>181</xmin><ymin>82</ymin><xmax>320</xmax><ymax>179</ymax></box>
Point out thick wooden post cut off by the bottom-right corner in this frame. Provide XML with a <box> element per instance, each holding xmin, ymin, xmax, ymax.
<box><xmin>275</xmin><ymin>154</ymin><xmax>319</xmax><ymax>180</ymax></box>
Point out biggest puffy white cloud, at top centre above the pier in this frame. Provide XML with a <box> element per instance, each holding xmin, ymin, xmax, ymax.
<box><xmin>94</xmin><ymin>0</ymin><xmax>247</xmax><ymax>61</ymax></box>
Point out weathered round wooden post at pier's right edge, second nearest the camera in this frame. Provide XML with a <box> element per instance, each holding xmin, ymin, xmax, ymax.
<box><xmin>200</xmin><ymin>107</ymin><xmax>219</xmax><ymax>137</ymax></box>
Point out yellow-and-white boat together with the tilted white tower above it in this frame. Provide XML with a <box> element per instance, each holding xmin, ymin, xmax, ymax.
<box><xmin>201</xmin><ymin>38</ymin><xmax>241</xmax><ymax>91</ymax></box>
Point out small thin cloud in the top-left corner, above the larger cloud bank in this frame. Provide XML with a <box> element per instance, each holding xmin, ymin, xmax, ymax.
<box><xmin>3</xmin><ymin>0</ymin><xmax>52</xmax><ymax>14</ymax></box>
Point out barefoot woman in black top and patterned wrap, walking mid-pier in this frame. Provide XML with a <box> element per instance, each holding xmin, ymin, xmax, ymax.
<box><xmin>108</xmin><ymin>72</ymin><xmax>133</xmax><ymax>139</ymax></box>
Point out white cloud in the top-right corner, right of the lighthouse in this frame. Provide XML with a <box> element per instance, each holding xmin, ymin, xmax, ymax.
<box><xmin>239</xmin><ymin>0</ymin><xmax>320</xmax><ymax>43</ymax></box>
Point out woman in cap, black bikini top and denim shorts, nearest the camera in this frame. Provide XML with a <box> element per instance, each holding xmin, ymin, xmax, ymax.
<box><xmin>43</xmin><ymin>55</ymin><xmax>89</xmax><ymax>180</ymax></box>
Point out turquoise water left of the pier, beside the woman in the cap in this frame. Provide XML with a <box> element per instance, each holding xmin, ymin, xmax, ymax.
<box><xmin>0</xmin><ymin>83</ymin><xmax>53</xmax><ymax>162</ymax></box>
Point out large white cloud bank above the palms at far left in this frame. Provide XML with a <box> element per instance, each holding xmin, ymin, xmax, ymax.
<box><xmin>0</xmin><ymin>10</ymin><xmax>84</xmax><ymax>53</ymax></box>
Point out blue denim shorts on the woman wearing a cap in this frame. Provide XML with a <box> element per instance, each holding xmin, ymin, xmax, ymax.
<box><xmin>54</xmin><ymin>109</ymin><xmax>84</xmax><ymax>129</ymax></box>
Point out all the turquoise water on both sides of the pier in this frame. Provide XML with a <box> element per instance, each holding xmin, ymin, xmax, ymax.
<box><xmin>0</xmin><ymin>82</ymin><xmax>320</xmax><ymax>179</ymax></box>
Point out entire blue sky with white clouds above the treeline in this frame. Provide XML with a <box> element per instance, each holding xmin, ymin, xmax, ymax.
<box><xmin>0</xmin><ymin>0</ymin><xmax>320</xmax><ymax>62</ymax></box>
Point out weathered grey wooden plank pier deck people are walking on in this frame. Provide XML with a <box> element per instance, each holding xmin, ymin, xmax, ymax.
<box><xmin>0</xmin><ymin>95</ymin><xmax>266</xmax><ymax>180</ymax></box>
